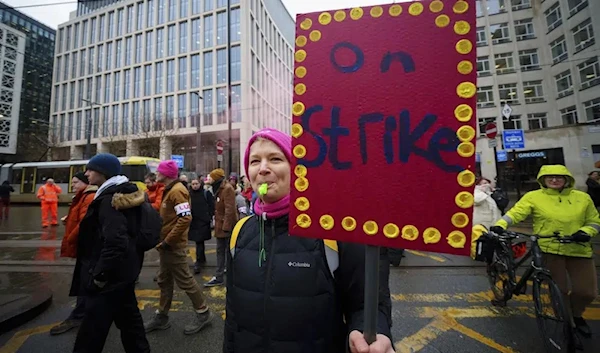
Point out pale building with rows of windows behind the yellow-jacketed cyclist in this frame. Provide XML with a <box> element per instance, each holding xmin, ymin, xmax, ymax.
<box><xmin>476</xmin><ymin>0</ymin><xmax>600</xmax><ymax>191</ymax></box>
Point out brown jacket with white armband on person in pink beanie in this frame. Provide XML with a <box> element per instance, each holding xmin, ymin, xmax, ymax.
<box><xmin>160</xmin><ymin>180</ymin><xmax>192</xmax><ymax>249</ymax></box>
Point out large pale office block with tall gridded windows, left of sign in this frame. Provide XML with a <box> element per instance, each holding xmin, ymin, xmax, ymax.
<box><xmin>51</xmin><ymin>0</ymin><xmax>295</xmax><ymax>172</ymax></box>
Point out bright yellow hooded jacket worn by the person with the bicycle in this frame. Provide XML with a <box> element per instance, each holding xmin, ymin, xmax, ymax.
<box><xmin>496</xmin><ymin>165</ymin><xmax>600</xmax><ymax>258</ymax></box>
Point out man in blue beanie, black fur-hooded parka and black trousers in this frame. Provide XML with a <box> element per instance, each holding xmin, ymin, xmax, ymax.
<box><xmin>70</xmin><ymin>153</ymin><xmax>150</xmax><ymax>353</ymax></box>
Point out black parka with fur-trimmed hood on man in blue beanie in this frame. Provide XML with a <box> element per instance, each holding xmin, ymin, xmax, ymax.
<box><xmin>70</xmin><ymin>179</ymin><xmax>145</xmax><ymax>296</ymax></box>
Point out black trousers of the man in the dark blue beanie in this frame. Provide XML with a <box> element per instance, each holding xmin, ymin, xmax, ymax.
<box><xmin>73</xmin><ymin>283</ymin><xmax>150</xmax><ymax>353</ymax></box>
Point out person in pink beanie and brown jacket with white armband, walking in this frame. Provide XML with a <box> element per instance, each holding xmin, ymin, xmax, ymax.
<box><xmin>144</xmin><ymin>160</ymin><xmax>212</xmax><ymax>335</ymax></box>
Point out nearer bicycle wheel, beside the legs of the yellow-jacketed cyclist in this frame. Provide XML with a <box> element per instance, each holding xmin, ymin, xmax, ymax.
<box><xmin>533</xmin><ymin>273</ymin><xmax>575</xmax><ymax>353</ymax></box>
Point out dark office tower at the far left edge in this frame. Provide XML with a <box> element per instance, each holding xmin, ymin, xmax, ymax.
<box><xmin>0</xmin><ymin>2</ymin><xmax>55</xmax><ymax>162</ymax></box>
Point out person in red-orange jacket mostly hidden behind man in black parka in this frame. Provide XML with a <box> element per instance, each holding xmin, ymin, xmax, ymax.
<box><xmin>50</xmin><ymin>172</ymin><xmax>98</xmax><ymax>336</ymax></box>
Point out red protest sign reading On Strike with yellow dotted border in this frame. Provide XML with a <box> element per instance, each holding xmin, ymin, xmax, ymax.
<box><xmin>290</xmin><ymin>1</ymin><xmax>476</xmax><ymax>255</ymax></box>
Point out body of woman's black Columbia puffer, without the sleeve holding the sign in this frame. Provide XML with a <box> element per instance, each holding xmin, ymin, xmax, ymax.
<box><xmin>224</xmin><ymin>216</ymin><xmax>348</xmax><ymax>353</ymax></box>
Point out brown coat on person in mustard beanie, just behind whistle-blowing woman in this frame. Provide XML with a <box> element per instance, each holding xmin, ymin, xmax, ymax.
<box><xmin>213</xmin><ymin>178</ymin><xmax>238</xmax><ymax>238</ymax></box>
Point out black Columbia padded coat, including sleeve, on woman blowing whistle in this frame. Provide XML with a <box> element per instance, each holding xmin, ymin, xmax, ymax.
<box><xmin>223</xmin><ymin>216</ymin><xmax>393</xmax><ymax>353</ymax></box>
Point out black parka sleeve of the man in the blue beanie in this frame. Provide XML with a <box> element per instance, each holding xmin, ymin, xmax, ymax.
<box><xmin>92</xmin><ymin>197</ymin><xmax>129</xmax><ymax>280</ymax></box>
